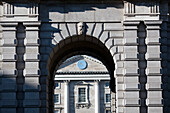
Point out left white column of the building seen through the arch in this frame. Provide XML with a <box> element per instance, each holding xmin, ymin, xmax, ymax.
<box><xmin>64</xmin><ymin>81</ymin><xmax>69</xmax><ymax>113</ymax></box>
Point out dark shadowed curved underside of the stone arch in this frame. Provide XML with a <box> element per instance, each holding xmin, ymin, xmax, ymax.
<box><xmin>48</xmin><ymin>35</ymin><xmax>115</xmax><ymax>112</ymax></box>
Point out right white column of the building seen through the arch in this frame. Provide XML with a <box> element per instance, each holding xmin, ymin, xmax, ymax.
<box><xmin>95</xmin><ymin>80</ymin><xmax>100</xmax><ymax>113</ymax></box>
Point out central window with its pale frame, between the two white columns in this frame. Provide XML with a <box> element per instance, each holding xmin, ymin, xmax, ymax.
<box><xmin>78</xmin><ymin>88</ymin><xmax>87</xmax><ymax>103</ymax></box>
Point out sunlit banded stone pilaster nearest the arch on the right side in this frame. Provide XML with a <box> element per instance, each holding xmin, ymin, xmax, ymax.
<box><xmin>123</xmin><ymin>21</ymin><xmax>140</xmax><ymax>113</ymax></box>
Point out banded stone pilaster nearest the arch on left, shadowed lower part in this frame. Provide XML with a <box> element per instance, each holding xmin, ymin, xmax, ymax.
<box><xmin>24</xmin><ymin>22</ymin><xmax>41</xmax><ymax>113</ymax></box>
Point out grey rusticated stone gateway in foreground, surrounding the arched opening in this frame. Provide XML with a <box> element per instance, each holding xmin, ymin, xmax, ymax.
<box><xmin>0</xmin><ymin>0</ymin><xmax>170</xmax><ymax>113</ymax></box>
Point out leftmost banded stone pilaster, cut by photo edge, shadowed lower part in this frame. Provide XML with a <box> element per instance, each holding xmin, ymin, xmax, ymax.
<box><xmin>0</xmin><ymin>22</ymin><xmax>18</xmax><ymax>113</ymax></box>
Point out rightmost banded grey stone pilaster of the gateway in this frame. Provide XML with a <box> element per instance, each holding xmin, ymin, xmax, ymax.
<box><xmin>145</xmin><ymin>21</ymin><xmax>163</xmax><ymax>113</ymax></box>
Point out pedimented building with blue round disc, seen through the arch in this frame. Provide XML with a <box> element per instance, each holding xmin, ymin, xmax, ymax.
<box><xmin>54</xmin><ymin>55</ymin><xmax>115</xmax><ymax>113</ymax></box>
